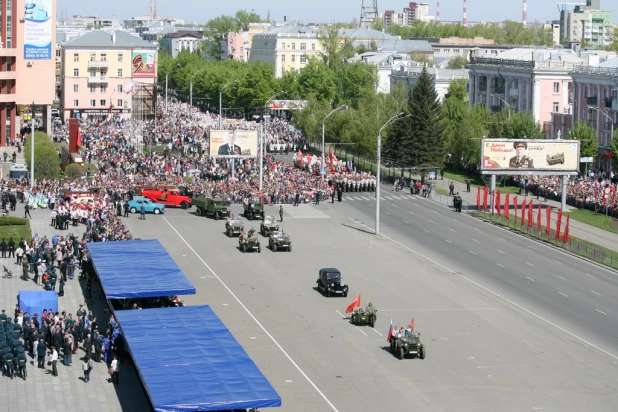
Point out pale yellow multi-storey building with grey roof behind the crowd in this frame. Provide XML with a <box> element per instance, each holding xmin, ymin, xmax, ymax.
<box><xmin>61</xmin><ymin>30</ymin><xmax>157</xmax><ymax>119</ymax></box>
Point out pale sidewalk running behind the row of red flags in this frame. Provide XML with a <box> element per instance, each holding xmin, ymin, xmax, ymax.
<box><xmin>424</xmin><ymin>178</ymin><xmax>618</xmax><ymax>250</ymax></box>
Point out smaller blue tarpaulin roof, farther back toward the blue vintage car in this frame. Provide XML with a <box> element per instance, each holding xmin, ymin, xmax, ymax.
<box><xmin>88</xmin><ymin>239</ymin><xmax>195</xmax><ymax>299</ymax></box>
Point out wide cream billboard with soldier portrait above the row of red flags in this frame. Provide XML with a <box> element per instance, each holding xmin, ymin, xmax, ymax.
<box><xmin>481</xmin><ymin>139</ymin><xmax>579</xmax><ymax>174</ymax></box>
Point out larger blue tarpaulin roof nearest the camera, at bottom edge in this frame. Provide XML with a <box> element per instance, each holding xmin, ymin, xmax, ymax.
<box><xmin>116</xmin><ymin>306</ymin><xmax>281</xmax><ymax>412</ymax></box>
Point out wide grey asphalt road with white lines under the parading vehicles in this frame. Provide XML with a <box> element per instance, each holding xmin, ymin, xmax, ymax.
<box><xmin>122</xmin><ymin>196</ymin><xmax>618</xmax><ymax>411</ymax></box>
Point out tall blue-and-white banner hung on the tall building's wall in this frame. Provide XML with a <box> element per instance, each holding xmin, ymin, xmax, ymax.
<box><xmin>24</xmin><ymin>0</ymin><xmax>55</xmax><ymax>60</ymax></box>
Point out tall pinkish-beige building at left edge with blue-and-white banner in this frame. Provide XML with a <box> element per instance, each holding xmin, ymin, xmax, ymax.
<box><xmin>0</xmin><ymin>0</ymin><xmax>56</xmax><ymax>146</ymax></box>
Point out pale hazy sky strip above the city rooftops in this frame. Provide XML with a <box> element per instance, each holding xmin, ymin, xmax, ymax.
<box><xmin>57</xmin><ymin>0</ymin><xmax>618</xmax><ymax>23</ymax></box>
